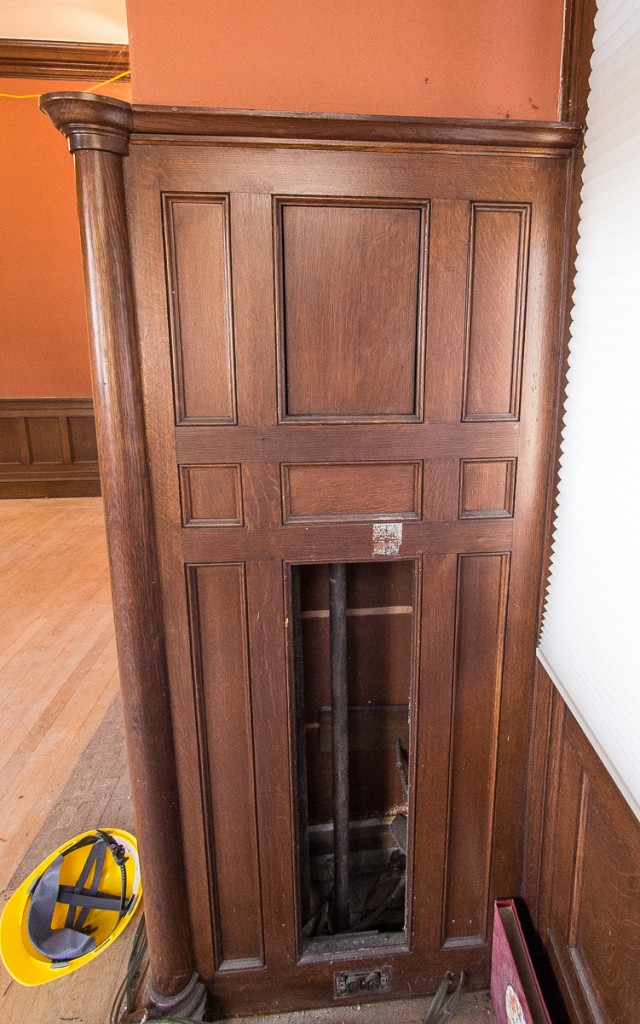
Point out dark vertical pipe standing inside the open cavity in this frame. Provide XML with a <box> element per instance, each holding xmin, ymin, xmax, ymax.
<box><xmin>329</xmin><ymin>562</ymin><xmax>349</xmax><ymax>932</ymax></box>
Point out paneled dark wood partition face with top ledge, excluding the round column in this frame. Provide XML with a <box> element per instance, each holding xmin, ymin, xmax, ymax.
<box><xmin>42</xmin><ymin>101</ymin><xmax>578</xmax><ymax>1014</ymax></box>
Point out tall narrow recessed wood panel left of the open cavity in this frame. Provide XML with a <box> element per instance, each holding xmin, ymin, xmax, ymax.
<box><xmin>188</xmin><ymin>564</ymin><xmax>262</xmax><ymax>967</ymax></box>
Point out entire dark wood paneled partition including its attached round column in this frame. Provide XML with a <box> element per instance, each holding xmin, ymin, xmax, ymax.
<box><xmin>37</xmin><ymin>95</ymin><xmax>577</xmax><ymax>1016</ymax></box>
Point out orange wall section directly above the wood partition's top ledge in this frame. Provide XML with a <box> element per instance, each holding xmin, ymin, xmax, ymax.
<box><xmin>127</xmin><ymin>0</ymin><xmax>563</xmax><ymax>121</ymax></box>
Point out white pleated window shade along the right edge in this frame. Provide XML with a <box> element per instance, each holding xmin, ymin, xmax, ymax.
<box><xmin>540</xmin><ymin>0</ymin><xmax>640</xmax><ymax>817</ymax></box>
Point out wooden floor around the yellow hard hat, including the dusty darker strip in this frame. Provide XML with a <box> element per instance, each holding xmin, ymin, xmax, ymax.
<box><xmin>0</xmin><ymin>498</ymin><xmax>496</xmax><ymax>1024</ymax></box>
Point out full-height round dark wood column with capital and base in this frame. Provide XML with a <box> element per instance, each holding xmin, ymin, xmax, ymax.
<box><xmin>40</xmin><ymin>93</ymin><xmax>205</xmax><ymax>1015</ymax></box>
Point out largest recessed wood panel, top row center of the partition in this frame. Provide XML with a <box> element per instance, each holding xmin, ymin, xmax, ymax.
<box><xmin>275</xmin><ymin>200</ymin><xmax>427</xmax><ymax>420</ymax></box>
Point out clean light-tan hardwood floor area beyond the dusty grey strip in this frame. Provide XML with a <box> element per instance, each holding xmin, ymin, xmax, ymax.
<box><xmin>0</xmin><ymin>499</ymin><xmax>118</xmax><ymax>888</ymax></box>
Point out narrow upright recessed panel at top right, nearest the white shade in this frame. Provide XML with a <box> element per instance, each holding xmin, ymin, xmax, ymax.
<box><xmin>463</xmin><ymin>203</ymin><xmax>529</xmax><ymax>421</ymax></box>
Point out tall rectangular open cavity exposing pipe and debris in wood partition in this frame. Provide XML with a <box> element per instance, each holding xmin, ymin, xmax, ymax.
<box><xmin>289</xmin><ymin>560</ymin><xmax>420</xmax><ymax>954</ymax></box>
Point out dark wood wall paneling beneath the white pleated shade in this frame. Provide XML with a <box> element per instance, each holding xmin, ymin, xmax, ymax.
<box><xmin>524</xmin><ymin>665</ymin><xmax>640</xmax><ymax>1024</ymax></box>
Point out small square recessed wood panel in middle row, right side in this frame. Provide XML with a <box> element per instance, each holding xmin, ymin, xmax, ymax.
<box><xmin>459</xmin><ymin>459</ymin><xmax>516</xmax><ymax>519</ymax></box>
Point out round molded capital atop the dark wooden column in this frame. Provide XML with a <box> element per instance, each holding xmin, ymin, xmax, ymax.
<box><xmin>40</xmin><ymin>92</ymin><xmax>133</xmax><ymax>156</ymax></box>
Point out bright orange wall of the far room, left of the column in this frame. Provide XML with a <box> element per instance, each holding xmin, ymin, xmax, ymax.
<box><xmin>0</xmin><ymin>79</ymin><xmax>130</xmax><ymax>398</ymax></box>
